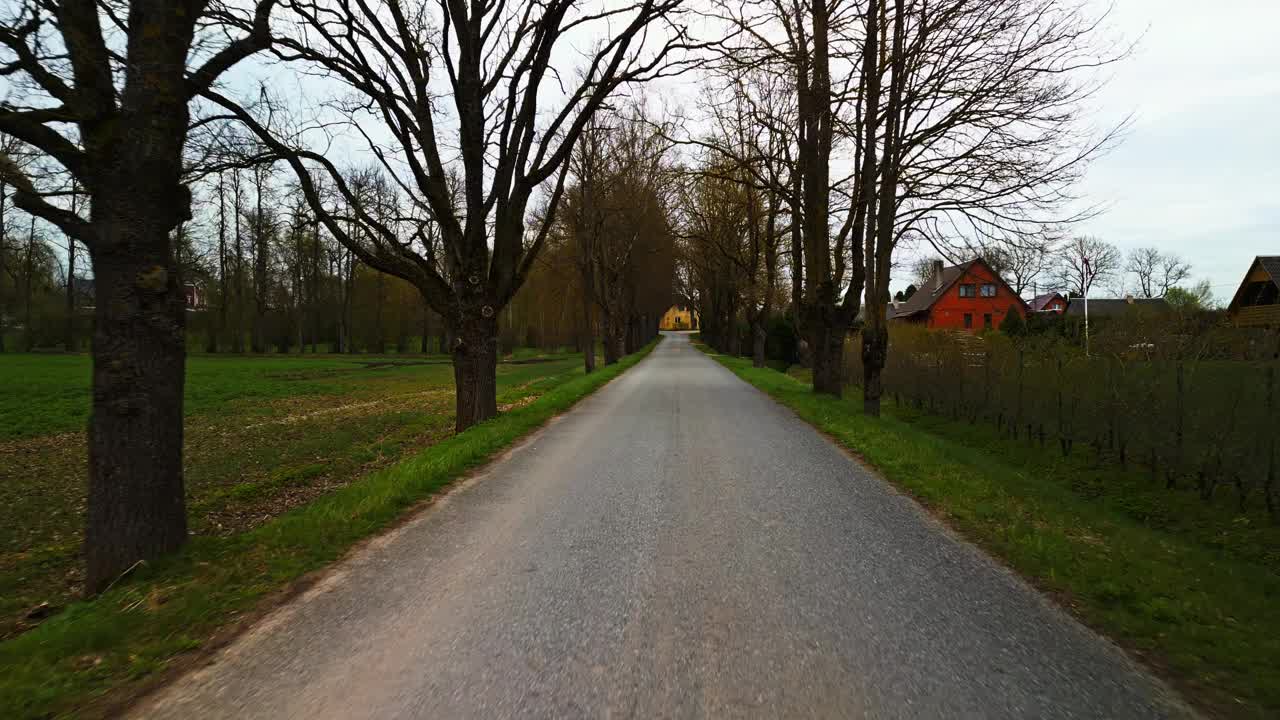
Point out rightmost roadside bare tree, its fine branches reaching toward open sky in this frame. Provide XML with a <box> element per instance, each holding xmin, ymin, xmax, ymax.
<box><xmin>860</xmin><ymin>0</ymin><xmax>1124</xmax><ymax>415</ymax></box>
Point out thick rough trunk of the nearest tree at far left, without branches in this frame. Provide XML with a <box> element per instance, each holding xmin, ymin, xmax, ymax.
<box><xmin>84</xmin><ymin>206</ymin><xmax>187</xmax><ymax>593</ymax></box>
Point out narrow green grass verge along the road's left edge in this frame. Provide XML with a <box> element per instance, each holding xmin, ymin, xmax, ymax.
<box><xmin>0</xmin><ymin>343</ymin><xmax>655</xmax><ymax>719</ymax></box>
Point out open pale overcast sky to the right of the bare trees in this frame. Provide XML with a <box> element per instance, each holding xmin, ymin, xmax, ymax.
<box><xmin>1080</xmin><ymin>0</ymin><xmax>1280</xmax><ymax>302</ymax></box>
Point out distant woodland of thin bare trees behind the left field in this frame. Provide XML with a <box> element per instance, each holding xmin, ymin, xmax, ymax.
<box><xmin>0</xmin><ymin>155</ymin><xmax>435</xmax><ymax>352</ymax></box>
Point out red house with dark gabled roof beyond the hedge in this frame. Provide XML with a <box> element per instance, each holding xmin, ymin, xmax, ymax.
<box><xmin>890</xmin><ymin>258</ymin><xmax>1028</xmax><ymax>333</ymax></box>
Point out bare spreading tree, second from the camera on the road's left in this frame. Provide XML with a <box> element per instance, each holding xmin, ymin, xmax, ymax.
<box><xmin>206</xmin><ymin>0</ymin><xmax>690</xmax><ymax>430</ymax></box>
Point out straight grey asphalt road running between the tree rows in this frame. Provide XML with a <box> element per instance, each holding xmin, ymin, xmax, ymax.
<box><xmin>136</xmin><ymin>336</ymin><xmax>1190</xmax><ymax>720</ymax></box>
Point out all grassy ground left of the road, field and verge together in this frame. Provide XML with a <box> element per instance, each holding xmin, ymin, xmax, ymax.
<box><xmin>0</xmin><ymin>346</ymin><xmax>652</xmax><ymax>719</ymax></box>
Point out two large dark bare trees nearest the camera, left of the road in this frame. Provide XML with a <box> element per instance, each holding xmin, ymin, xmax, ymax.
<box><xmin>0</xmin><ymin>0</ymin><xmax>700</xmax><ymax>593</ymax></box>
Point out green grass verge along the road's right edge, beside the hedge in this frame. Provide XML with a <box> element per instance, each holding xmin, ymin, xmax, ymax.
<box><xmin>701</xmin><ymin>346</ymin><xmax>1280</xmax><ymax>719</ymax></box>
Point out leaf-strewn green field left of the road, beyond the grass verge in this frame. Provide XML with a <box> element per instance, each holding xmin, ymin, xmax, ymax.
<box><xmin>0</xmin><ymin>354</ymin><xmax>596</xmax><ymax>639</ymax></box>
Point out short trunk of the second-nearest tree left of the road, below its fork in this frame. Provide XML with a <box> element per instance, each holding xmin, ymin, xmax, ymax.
<box><xmin>452</xmin><ymin>316</ymin><xmax>498</xmax><ymax>433</ymax></box>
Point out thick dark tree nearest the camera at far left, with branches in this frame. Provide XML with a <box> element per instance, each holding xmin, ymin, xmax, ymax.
<box><xmin>0</xmin><ymin>0</ymin><xmax>275</xmax><ymax>592</ymax></box>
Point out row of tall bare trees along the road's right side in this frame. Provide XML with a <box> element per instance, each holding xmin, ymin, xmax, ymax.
<box><xmin>680</xmin><ymin>0</ymin><xmax>1123</xmax><ymax>415</ymax></box>
